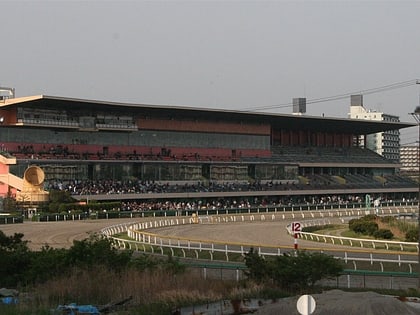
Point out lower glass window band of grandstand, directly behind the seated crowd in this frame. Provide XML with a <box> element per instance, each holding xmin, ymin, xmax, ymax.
<box><xmin>10</xmin><ymin>161</ymin><xmax>298</xmax><ymax>182</ymax></box>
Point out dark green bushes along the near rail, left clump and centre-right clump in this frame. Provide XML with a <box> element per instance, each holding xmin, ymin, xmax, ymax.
<box><xmin>0</xmin><ymin>227</ymin><xmax>343</xmax><ymax>290</ymax></box>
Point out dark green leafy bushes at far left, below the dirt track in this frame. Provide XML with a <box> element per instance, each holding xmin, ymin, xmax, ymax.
<box><xmin>0</xmin><ymin>231</ymin><xmax>136</xmax><ymax>287</ymax></box>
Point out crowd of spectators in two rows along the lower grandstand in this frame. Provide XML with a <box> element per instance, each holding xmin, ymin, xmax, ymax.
<box><xmin>42</xmin><ymin>180</ymin><xmax>414</xmax><ymax>212</ymax></box>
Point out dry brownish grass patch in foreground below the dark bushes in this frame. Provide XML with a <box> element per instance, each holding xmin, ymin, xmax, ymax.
<box><xmin>0</xmin><ymin>268</ymin><xmax>288</xmax><ymax>315</ymax></box>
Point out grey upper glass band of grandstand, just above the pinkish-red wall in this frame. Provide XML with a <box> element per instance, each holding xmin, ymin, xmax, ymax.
<box><xmin>0</xmin><ymin>127</ymin><xmax>270</xmax><ymax>150</ymax></box>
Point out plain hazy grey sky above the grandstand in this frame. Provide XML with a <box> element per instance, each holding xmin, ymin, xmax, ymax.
<box><xmin>0</xmin><ymin>0</ymin><xmax>420</xmax><ymax>144</ymax></box>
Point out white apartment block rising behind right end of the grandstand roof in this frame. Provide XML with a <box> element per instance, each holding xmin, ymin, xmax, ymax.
<box><xmin>349</xmin><ymin>95</ymin><xmax>400</xmax><ymax>163</ymax></box>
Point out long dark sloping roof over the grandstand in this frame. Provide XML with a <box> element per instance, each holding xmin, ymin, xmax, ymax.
<box><xmin>0</xmin><ymin>95</ymin><xmax>417</xmax><ymax>135</ymax></box>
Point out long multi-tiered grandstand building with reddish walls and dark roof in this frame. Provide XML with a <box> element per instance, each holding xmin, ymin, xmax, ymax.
<box><xmin>0</xmin><ymin>95</ymin><xmax>418</xmax><ymax>200</ymax></box>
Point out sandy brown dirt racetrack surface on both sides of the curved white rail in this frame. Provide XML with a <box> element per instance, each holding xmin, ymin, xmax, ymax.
<box><xmin>0</xmin><ymin>219</ymin><xmax>311</xmax><ymax>250</ymax></box>
